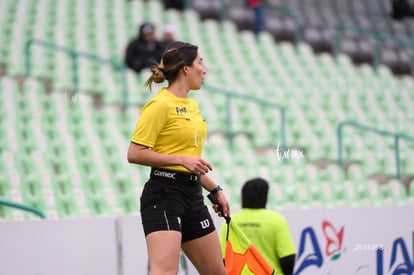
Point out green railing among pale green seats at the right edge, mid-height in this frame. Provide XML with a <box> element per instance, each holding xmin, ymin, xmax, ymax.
<box><xmin>337</xmin><ymin>120</ymin><xmax>414</xmax><ymax>181</ymax></box>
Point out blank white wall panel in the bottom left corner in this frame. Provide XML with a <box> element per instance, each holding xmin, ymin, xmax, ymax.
<box><xmin>0</xmin><ymin>218</ymin><xmax>120</xmax><ymax>275</ymax></box>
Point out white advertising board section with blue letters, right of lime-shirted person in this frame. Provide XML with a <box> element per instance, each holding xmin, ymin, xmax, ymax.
<box><xmin>282</xmin><ymin>206</ymin><xmax>414</xmax><ymax>275</ymax></box>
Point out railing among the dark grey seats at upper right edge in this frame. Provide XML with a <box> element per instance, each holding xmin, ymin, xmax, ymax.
<box><xmin>333</xmin><ymin>24</ymin><xmax>414</xmax><ymax>72</ymax></box>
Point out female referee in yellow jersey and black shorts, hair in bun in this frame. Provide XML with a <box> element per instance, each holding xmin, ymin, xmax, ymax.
<box><xmin>128</xmin><ymin>41</ymin><xmax>230</xmax><ymax>275</ymax></box>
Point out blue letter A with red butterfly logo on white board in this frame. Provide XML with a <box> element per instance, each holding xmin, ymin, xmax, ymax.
<box><xmin>294</xmin><ymin>220</ymin><xmax>345</xmax><ymax>275</ymax></box>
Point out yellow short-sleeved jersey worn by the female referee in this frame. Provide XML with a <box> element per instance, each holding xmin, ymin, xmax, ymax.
<box><xmin>131</xmin><ymin>88</ymin><xmax>207</xmax><ymax>172</ymax></box>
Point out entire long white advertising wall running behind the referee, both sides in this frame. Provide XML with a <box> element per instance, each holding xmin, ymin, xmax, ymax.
<box><xmin>0</xmin><ymin>206</ymin><xmax>414</xmax><ymax>275</ymax></box>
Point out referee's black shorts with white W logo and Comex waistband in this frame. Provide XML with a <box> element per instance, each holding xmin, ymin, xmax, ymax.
<box><xmin>141</xmin><ymin>169</ymin><xmax>215</xmax><ymax>242</ymax></box>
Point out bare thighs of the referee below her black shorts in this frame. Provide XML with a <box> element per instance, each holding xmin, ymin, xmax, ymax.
<box><xmin>146</xmin><ymin>231</ymin><xmax>227</xmax><ymax>275</ymax></box>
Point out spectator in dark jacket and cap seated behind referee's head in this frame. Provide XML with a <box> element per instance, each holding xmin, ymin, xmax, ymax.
<box><xmin>125</xmin><ymin>23</ymin><xmax>164</xmax><ymax>73</ymax></box>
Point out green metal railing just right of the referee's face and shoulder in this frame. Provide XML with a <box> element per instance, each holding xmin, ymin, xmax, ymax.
<box><xmin>203</xmin><ymin>84</ymin><xmax>287</xmax><ymax>156</ymax></box>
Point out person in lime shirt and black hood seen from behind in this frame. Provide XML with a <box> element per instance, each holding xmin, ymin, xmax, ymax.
<box><xmin>220</xmin><ymin>178</ymin><xmax>296</xmax><ymax>275</ymax></box>
